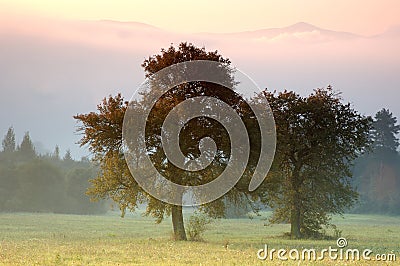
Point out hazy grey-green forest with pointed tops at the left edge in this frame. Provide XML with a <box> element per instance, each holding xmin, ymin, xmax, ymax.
<box><xmin>0</xmin><ymin>130</ymin><xmax>106</xmax><ymax>214</ymax></box>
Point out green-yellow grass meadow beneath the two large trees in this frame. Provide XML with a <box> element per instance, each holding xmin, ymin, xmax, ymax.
<box><xmin>0</xmin><ymin>213</ymin><xmax>400</xmax><ymax>265</ymax></box>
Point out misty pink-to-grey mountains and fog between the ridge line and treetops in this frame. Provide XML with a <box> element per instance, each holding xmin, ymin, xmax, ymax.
<box><xmin>0</xmin><ymin>19</ymin><xmax>400</xmax><ymax>160</ymax></box>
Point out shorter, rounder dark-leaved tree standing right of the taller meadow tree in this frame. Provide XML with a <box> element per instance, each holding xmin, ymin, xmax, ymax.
<box><xmin>264</xmin><ymin>87</ymin><xmax>371</xmax><ymax>238</ymax></box>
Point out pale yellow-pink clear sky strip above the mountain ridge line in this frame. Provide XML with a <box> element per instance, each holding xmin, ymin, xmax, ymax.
<box><xmin>0</xmin><ymin>0</ymin><xmax>400</xmax><ymax>35</ymax></box>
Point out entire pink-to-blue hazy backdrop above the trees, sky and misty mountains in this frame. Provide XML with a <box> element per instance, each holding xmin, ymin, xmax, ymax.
<box><xmin>0</xmin><ymin>0</ymin><xmax>400</xmax><ymax>159</ymax></box>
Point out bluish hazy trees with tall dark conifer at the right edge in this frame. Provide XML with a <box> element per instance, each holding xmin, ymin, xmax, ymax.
<box><xmin>354</xmin><ymin>109</ymin><xmax>400</xmax><ymax>214</ymax></box>
